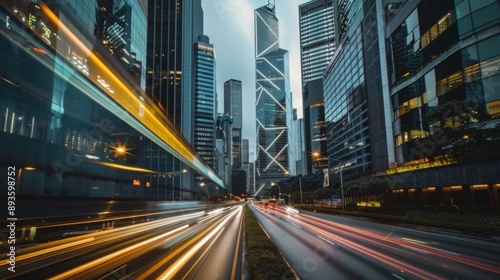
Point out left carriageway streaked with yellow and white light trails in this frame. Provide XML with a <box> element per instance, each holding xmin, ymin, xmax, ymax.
<box><xmin>0</xmin><ymin>205</ymin><xmax>243</xmax><ymax>279</ymax></box>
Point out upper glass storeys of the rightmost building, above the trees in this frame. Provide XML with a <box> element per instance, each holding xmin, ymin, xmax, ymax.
<box><xmin>388</xmin><ymin>0</ymin><xmax>500</xmax><ymax>165</ymax></box>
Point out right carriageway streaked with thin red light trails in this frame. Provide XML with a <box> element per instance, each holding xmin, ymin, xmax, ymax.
<box><xmin>250</xmin><ymin>203</ymin><xmax>500</xmax><ymax>280</ymax></box>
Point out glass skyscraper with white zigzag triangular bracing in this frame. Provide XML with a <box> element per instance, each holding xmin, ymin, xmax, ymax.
<box><xmin>254</xmin><ymin>4</ymin><xmax>291</xmax><ymax>184</ymax></box>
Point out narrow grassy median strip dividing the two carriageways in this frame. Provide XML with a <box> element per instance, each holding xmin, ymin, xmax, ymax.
<box><xmin>245</xmin><ymin>206</ymin><xmax>296</xmax><ymax>280</ymax></box>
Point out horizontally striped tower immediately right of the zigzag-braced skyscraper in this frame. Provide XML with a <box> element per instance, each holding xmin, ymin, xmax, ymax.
<box><xmin>299</xmin><ymin>0</ymin><xmax>335</xmax><ymax>173</ymax></box>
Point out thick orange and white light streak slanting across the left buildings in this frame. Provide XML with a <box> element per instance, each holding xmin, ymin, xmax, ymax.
<box><xmin>1</xmin><ymin>3</ymin><xmax>226</xmax><ymax>188</ymax></box>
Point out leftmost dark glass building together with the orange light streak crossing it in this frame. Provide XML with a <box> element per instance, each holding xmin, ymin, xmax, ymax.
<box><xmin>0</xmin><ymin>1</ymin><xmax>223</xmax><ymax>200</ymax></box>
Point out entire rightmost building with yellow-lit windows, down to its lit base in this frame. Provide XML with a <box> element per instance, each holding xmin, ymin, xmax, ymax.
<box><xmin>385</xmin><ymin>0</ymin><xmax>500</xmax><ymax>211</ymax></box>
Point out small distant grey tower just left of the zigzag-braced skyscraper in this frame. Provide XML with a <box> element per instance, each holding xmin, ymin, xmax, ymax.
<box><xmin>224</xmin><ymin>79</ymin><xmax>243</xmax><ymax>169</ymax></box>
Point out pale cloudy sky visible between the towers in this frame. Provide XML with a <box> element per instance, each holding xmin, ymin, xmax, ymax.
<box><xmin>202</xmin><ymin>0</ymin><xmax>310</xmax><ymax>159</ymax></box>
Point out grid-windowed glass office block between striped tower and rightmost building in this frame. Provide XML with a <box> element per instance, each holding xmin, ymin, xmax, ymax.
<box><xmin>323</xmin><ymin>0</ymin><xmax>394</xmax><ymax>175</ymax></box>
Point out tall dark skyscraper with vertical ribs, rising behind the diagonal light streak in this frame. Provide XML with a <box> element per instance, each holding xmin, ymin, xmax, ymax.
<box><xmin>146</xmin><ymin>0</ymin><xmax>214</xmax><ymax>200</ymax></box>
